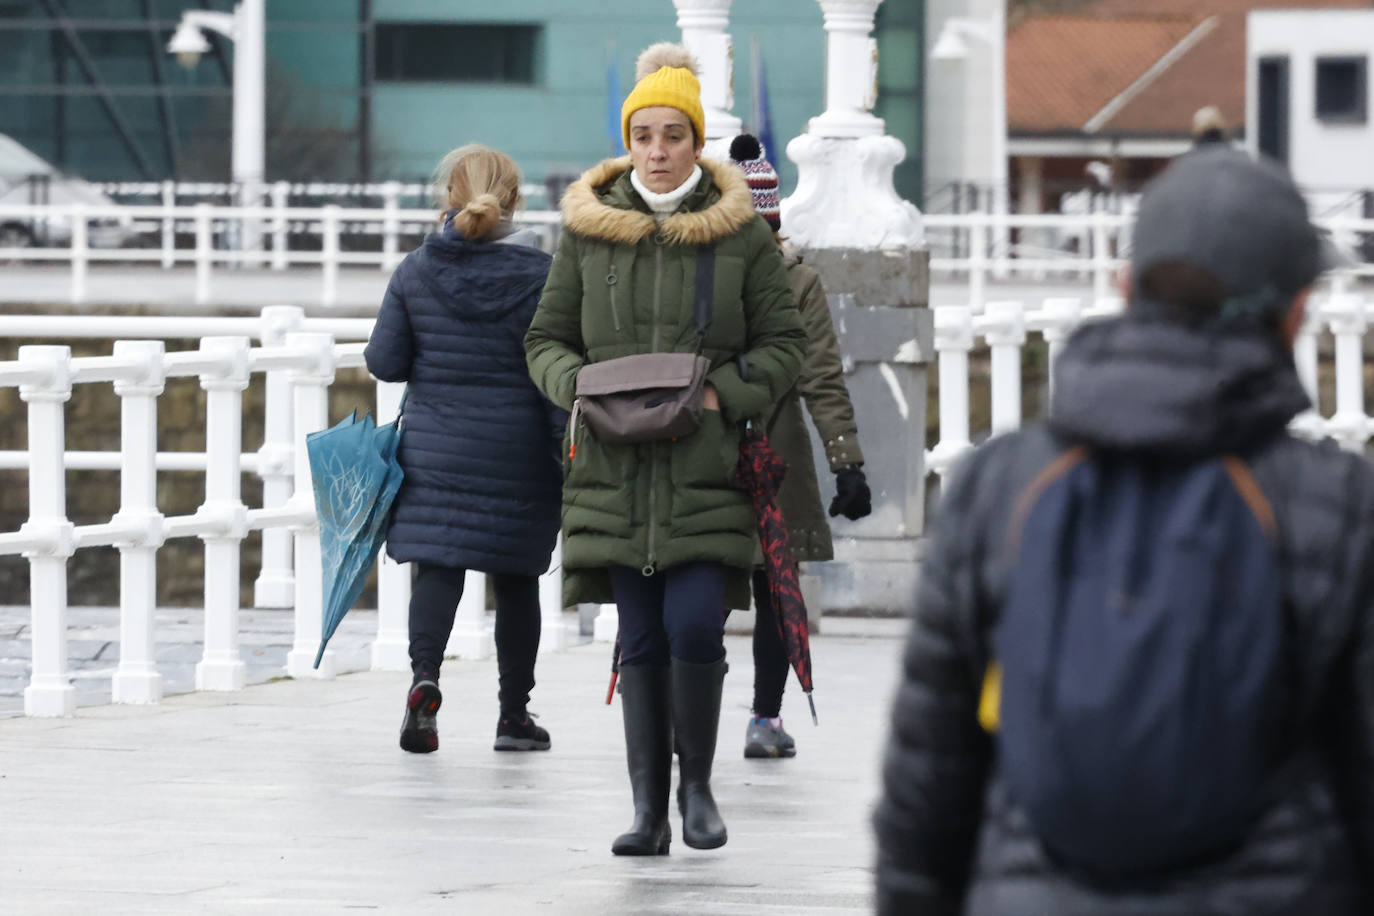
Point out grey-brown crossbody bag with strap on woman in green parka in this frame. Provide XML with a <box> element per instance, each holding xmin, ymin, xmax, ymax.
<box><xmin>570</xmin><ymin>246</ymin><xmax>716</xmax><ymax>448</ymax></box>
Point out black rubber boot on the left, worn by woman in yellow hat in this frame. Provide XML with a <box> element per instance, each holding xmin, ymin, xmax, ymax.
<box><xmin>610</xmin><ymin>665</ymin><xmax>673</xmax><ymax>856</ymax></box>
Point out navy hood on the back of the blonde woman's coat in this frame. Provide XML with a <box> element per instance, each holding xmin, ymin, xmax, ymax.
<box><xmin>414</xmin><ymin>228</ymin><xmax>552</xmax><ymax>320</ymax></box>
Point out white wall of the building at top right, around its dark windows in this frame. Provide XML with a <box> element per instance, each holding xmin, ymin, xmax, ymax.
<box><xmin>1245</xmin><ymin>10</ymin><xmax>1374</xmax><ymax>213</ymax></box>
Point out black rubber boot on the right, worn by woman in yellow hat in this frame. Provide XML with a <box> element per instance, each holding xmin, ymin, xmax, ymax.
<box><xmin>672</xmin><ymin>658</ymin><xmax>725</xmax><ymax>849</ymax></box>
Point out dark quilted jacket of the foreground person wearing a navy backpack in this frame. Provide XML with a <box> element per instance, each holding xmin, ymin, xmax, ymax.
<box><xmin>874</xmin><ymin>317</ymin><xmax>1374</xmax><ymax>916</ymax></box>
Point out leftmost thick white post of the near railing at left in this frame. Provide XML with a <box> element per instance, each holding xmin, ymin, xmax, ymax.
<box><xmin>19</xmin><ymin>346</ymin><xmax>77</xmax><ymax>715</ymax></box>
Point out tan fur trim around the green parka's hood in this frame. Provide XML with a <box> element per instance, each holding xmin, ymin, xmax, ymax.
<box><xmin>562</xmin><ymin>157</ymin><xmax>756</xmax><ymax>244</ymax></box>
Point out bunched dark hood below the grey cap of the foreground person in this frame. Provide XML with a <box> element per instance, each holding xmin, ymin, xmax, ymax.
<box><xmin>1050</xmin><ymin>314</ymin><xmax>1311</xmax><ymax>459</ymax></box>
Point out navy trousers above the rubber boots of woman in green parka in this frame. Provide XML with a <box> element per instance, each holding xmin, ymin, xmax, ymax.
<box><xmin>610</xmin><ymin>563</ymin><xmax>725</xmax><ymax>666</ymax></box>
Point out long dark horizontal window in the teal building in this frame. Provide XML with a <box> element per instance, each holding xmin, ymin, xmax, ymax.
<box><xmin>376</xmin><ymin>22</ymin><xmax>540</xmax><ymax>84</ymax></box>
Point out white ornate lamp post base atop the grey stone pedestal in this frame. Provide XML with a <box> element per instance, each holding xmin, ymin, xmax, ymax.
<box><xmin>782</xmin><ymin>0</ymin><xmax>925</xmax><ymax>250</ymax></box>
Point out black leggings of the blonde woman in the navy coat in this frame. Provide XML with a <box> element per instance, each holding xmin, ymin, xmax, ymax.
<box><xmin>411</xmin><ymin>563</ymin><xmax>540</xmax><ymax>720</ymax></box>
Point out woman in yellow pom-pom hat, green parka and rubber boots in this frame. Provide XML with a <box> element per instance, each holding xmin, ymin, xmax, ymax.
<box><xmin>525</xmin><ymin>44</ymin><xmax>805</xmax><ymax>856</ymax></box>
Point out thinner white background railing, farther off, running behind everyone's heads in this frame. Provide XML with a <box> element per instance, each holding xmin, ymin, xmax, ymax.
<box><xmin>0</xmin><ymin>200</ymin><xmax>1374</xmax><ymax>311</ymax></box>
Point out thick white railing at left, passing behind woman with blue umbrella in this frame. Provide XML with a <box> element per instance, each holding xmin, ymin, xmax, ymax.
<box><xmin>0</xmin><ymin>306</ymin><xmax>567</xmax><ymax>715</ymax></box>
